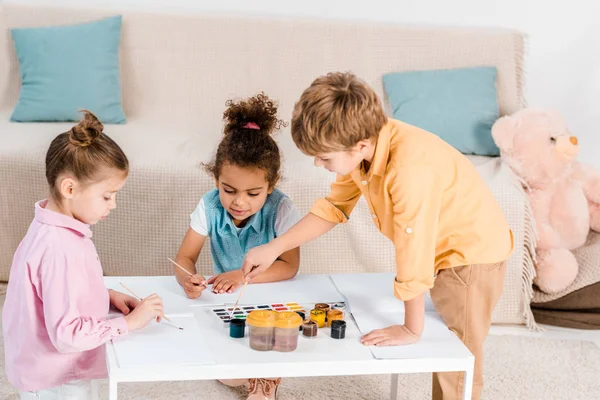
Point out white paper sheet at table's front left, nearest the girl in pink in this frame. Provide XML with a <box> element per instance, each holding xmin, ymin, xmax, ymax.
<box><xmin>107</xmin><ymin>316</ymin><xmax>215</xmax><ymax>368</ymax></box>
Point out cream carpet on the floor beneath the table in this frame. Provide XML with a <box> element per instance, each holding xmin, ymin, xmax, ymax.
<box><xmin>0</xmin><ymin>288</ymin><xmax>600</xmax><ymax>400</ymax></box>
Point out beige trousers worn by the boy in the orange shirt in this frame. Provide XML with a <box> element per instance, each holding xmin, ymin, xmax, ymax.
<box><xmin>431</xmin><ymin>261</ymin><xmax>506</xmax><ymax>400</ymax></box>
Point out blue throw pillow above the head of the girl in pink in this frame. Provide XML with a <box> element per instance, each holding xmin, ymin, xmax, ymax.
<box><xmin>10</xmin><ymin>16</ymin><xmax>125</xmax><ymax>124</ymax></box>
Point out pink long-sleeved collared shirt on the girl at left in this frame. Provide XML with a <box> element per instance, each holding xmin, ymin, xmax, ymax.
<box><xmin>2</xmin><ymin>200</ymin><xmax>127</xmax><ymax>391</ymax></box>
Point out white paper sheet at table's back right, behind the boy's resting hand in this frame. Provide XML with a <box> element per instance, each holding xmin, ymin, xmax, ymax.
<box><xmin>331</xmin><ymin>273</ymin><xmax>435</xmax><ymax>313</ymax></box>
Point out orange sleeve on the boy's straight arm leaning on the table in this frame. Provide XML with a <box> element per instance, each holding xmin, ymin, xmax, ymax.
<box><xmin>389</xmin><ymin>166</ymin><xmax>442</xmax><ymax>301</ymax></box>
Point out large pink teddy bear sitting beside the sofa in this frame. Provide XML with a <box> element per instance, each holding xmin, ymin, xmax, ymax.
<box><xmin>492</xmin><ymin>109</ymin><xmax>600</xmax><ymax>293</ymax></box>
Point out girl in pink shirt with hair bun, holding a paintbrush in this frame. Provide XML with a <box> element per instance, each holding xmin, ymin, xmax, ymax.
<box><xmin>2</xmin><ymin>112</ymin><xmax>163</xmax><ymax>399</ymax></box>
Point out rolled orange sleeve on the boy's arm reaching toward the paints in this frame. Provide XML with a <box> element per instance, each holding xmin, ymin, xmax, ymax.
<box><xmin>310</xmin><ymin>174</ymin><xmax>362</xmax><ymax>224</ymax></box>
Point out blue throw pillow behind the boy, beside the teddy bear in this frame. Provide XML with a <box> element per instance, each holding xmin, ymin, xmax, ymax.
<box><xmin>383</xmin><ymin>67</ymin><xmax>500</xmax><ymax>156</ymax></box>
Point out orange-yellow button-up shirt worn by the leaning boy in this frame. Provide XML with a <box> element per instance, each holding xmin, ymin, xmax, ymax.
<box><xmin>311</xmin><ymin>119</ymin><xmax>513</xmax><ymax>301</ymax></box>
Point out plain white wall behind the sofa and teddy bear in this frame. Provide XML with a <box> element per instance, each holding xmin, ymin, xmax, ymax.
<box><xmin>0</xmin><ymin>0</ymin><xmax>600</xmax><ymax>169</ymax></box>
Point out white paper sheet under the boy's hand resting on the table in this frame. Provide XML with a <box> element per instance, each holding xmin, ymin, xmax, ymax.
<box><xmin>352</xmin><ymin>311</ymin><xmax>470</xmax><ymax>359</ymax></box>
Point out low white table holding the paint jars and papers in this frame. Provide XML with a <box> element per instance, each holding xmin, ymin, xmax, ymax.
<box><xmin>106</xmin><ymin>276</ymin><xmax>474</xmax><ymax>400</ymax></box>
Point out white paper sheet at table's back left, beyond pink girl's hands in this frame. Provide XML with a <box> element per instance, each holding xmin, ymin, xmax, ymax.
<box><xmin>104</xmin><ymin>276</ymin><xmax>195</xmax><ymax>318</ymax></box>
